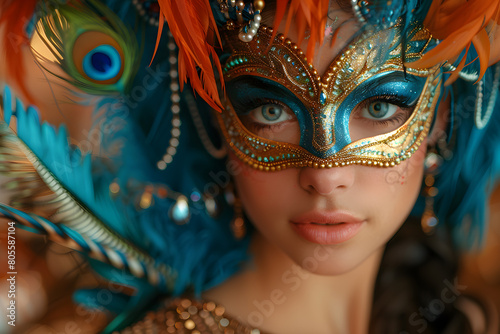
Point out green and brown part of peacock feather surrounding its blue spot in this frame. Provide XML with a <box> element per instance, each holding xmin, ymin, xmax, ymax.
<box><xmin>34</xmin><ymin>0</ymin><xmax>140</xmax><ymax>95</ymax></box>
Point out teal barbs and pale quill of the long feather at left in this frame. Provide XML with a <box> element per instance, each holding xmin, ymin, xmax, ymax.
<box><xmin>0</xmin><ymin>87</ymin><xmax>175</xmax><ymax>290</ymax></box>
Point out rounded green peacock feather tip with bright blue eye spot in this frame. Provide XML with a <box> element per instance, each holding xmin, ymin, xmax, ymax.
<box><xmin>35</xmin><ymin>0</ymin><xmax>141</xmax><ymax>95</ymax></box>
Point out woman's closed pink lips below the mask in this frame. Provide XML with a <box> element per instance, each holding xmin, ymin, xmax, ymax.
<box><xmin>290</xmin><ymin>211</ymin><xmax>364</xmax><ymax>245</ymax></box>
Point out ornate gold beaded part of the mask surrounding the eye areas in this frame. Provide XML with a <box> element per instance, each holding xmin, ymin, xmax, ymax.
<box><xmin>218</xmin><ymin>23</ymin><xmax>441</xmax><ymax>171</ymax></box>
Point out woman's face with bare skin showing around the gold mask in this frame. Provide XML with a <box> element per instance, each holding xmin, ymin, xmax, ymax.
<box><xmin>225</xmin><ymin>2</ymin><xmax>427</xmax><ymax>275</ymax></box>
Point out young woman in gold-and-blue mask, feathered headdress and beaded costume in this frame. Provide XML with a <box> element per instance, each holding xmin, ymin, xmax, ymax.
<box><xmin>0</xmin><ymin>0</ymin><xmax>500</xmax><ymax>333</ymax></box>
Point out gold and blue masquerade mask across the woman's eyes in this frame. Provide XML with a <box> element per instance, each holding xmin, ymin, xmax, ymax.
<box><xmin>217</xmin><ymin>23</ymin><xmax>441</xmax><ymax>171</ymax></box>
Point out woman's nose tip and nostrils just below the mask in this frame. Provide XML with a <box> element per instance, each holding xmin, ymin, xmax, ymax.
<box><xmin>299</xmin><ymin>166</ymin><xmax>355</xmax><ymax>196</ymax></box>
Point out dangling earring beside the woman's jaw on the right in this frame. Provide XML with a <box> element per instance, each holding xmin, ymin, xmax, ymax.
<box><xmin>421</xmin><ymin>151</ymin><xmax>443</xmax><ymax>235</ymax></box>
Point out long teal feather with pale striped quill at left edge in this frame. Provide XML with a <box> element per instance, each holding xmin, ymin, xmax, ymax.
<box><xmin>0</xmin><ymin>87</ymin><xmax>176</xmax><ymax>291</ymax></box>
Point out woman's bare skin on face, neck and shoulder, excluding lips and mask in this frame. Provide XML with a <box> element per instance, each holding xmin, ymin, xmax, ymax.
<box><xmin>204</xmin><ymin>4</ymin><xmax>447</xmax><ymax>334</ymax></box>
